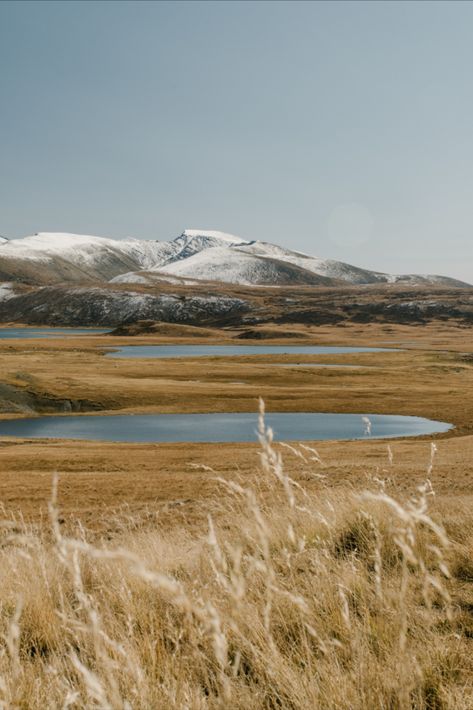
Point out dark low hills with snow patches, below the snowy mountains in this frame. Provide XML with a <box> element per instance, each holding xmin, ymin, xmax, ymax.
<box><xmin>0</xmin><ymin>282</ymin><xmax>473</xmax><ymax>330</ymax></box>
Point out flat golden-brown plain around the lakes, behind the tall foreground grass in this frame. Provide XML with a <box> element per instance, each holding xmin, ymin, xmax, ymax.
<box><xmin>0</xmin><ymin>325</ymin><xmax>473</xmax><ymax>526</ymax></box>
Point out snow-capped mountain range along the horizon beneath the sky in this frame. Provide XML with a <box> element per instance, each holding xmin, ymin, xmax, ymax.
<box><xmin>0</xmin><ymin>230</ymin><xmax>467</xmax><ymax>286</ymax></box>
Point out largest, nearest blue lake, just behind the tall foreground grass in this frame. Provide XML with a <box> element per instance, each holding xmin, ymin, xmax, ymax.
<box><xmin>0</xmin><ymin>412</ymin><xmax>451</xmax><ymax>443</ymax></box>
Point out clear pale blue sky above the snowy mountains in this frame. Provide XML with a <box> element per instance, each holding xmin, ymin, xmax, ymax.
<box><xmin>0</xmin><ymin>0</ymin><xmax>473</xmax><ymax>282</ymax></box>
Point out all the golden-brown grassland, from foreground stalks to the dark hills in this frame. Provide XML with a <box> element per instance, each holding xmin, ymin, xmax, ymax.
<box><xmin>0</xmin><ymin>326</ymin><xmax>473</xmax><ymax>710</ymax></box>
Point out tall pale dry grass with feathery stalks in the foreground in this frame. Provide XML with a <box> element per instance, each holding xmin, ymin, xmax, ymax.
<box><xmin>0</xmin><ymin>408</ymin><xmax>473</xmax><ymax>710</ymax></box>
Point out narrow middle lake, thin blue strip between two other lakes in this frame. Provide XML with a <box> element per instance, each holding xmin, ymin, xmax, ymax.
<box><xmin>108</xmin><ymin>345</ymin><xmax>399</xmax><ymax>358</ymax></box>
